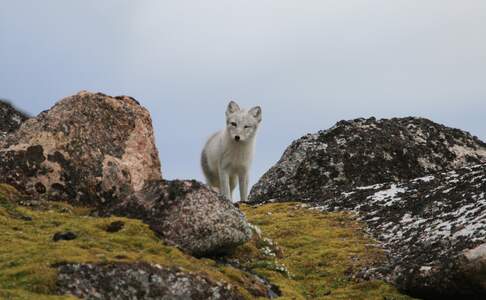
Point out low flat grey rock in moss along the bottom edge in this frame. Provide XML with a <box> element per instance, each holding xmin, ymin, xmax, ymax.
<box><xmin>57</xmin><ymin>263</ymin><xmax>244</xmax><ymax>300</ymax></box>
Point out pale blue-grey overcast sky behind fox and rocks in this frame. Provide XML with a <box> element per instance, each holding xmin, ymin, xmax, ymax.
<box><xmin>0</xmin><ymin>0</ymin><xmax>486</xmax><ymax>197</ymax></box>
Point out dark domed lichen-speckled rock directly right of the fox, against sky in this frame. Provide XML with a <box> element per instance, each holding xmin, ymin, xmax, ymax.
<box><xmin>249</xmin><ymin>118</ymin><xmax>486</xmax><ymax>203</ymax></box>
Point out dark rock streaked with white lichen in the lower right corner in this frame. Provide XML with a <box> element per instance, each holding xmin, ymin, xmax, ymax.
<box><xmin>313</xmin><ymin>164</ymin><xmax>486</xmax><ymax>299</ymax></box>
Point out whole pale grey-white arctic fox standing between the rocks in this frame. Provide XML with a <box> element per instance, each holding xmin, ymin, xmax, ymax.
<box><xmin>201</xmin><ymin>101</ymin><xmax>262</xmax><ymax>202</ymax></box>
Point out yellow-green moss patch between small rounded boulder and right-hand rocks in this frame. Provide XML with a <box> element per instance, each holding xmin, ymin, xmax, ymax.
<box><xmin>234</xmin><ymin>203</ymin><xmax>411</xmax><ymax>299</ymax></box>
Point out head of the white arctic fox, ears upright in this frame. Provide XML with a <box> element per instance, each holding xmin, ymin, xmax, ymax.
<box><xmin>226</xmin><ymin>101</ymin><xmax>262</xmax><ymax>142</ymax></box>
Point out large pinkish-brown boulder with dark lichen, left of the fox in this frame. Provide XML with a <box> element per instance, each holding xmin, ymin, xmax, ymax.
<box><xmin>0</xmin><ymin>91</ymin><xmax>161</xmax><ymax>205</ymax></box>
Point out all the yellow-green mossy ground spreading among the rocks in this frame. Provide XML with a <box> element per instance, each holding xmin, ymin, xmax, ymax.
<box><xmin>0</xmin><ymin>184</ymin><xmax>414</xmax><ymax>300</ymax></box>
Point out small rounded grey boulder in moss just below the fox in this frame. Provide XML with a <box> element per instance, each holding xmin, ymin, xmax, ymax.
<box><xmin>102</xmin><ymin>180</ymin><xmax>252</xmax><ymax>256</ymax></box>
